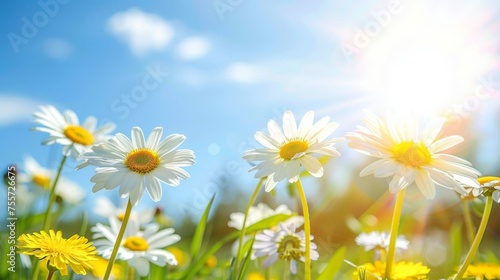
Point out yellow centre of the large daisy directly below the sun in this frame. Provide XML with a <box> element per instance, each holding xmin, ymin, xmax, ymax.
<box><xmin>391</xmin><ymin>141</ymin><xmax>432</xmax><ymax>168</ymax></box>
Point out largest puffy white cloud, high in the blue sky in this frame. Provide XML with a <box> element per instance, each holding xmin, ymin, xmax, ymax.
<box><xmin>107</xmin><ymin>8</ymin><xmax>174</xmax><ymax>56</ymax></box>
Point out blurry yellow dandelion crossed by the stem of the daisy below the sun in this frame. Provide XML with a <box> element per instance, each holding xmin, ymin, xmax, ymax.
<box><xmin>352</xmin><ymin>261</ymin><xmax>431</xmax><ymax>280</ymax></box>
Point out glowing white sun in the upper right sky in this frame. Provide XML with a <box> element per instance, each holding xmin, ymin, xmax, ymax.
<box><xmin>361</xmin><ymin>1</ymin><xmax>494</xmax><ymax>114</ymax></box>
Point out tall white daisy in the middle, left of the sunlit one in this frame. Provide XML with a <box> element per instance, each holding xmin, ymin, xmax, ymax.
<box><xmin>243</xmin><ymin>111</ymin><xmax>341</xmax><ymax>192</ymax></box>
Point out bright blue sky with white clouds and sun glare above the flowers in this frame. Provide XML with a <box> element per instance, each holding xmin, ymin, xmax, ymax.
<box><xmin>0</xmin><ymin>0</ymin><xmax>500</xmax><ymax>222</ymax></box>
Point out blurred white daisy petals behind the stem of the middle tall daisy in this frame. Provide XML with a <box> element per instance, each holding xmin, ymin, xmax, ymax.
<box><xmin>227</xmin><ymin>203</ymin><xmax>304</xmax><ymax>230</ymax></box>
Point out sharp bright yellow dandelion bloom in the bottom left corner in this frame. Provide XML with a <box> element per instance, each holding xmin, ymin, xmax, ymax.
<box><xmin>18</xmin><ymin>230</ymin><xmax>97</xmax><ymax>276</ymax></box>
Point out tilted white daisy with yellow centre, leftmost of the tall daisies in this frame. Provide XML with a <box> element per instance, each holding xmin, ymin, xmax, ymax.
<box><xmin>34</xmin><ymin>105</ymin><xmax>115</xmax><ymax>159</ymax></box>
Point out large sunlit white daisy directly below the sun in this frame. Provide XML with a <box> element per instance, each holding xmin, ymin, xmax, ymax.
<box><xmin>346</xmin><ymin>111</ymin><xmax>480</xmax><ymax>199</ymax></box>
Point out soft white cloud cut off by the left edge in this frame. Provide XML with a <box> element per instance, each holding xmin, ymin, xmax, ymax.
<box><xmin>0</xmin><ymin>93</ymin><xmax>41</xmax><ymax>126</ymax></box>
